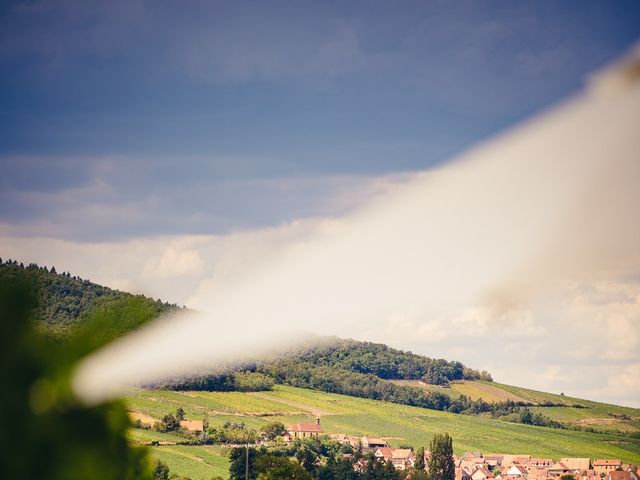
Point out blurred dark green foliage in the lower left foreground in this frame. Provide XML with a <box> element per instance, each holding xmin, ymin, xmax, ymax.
<box><xmin>0</xmin><ymin>275</ymin><xmax>153</xmax><ymax>480</ymax></box>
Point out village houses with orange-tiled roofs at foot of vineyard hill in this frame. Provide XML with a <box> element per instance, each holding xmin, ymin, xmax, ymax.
<box><xmin>283</xmin><ymin>418</ymin><xmax>640</xmax><ymax>480</ymax></box>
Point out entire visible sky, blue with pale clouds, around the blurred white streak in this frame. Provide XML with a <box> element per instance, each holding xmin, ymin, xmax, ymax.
<box><xmin>0</xmin><ymin>0</ymin><xmax>640</xmax><ymax>405</ymax></box>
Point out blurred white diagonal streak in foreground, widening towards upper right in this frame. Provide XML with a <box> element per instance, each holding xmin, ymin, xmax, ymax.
<box><xmin>74</xmin><ymin>46</ymin><xmax>640</xmax><ymax>402</ymax></box>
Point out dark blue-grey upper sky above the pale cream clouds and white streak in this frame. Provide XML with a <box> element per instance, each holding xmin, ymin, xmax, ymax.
<box><xmin>0</xmin><ymin>1</ymin><xmax>640</xmax><ymax>241</ymax></box>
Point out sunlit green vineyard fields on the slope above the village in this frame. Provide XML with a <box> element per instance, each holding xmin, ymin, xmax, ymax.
<box><xmin>127</xmin><ymin>384</ymin><xmax>640</xmax><ymax>480</ymax></box>
